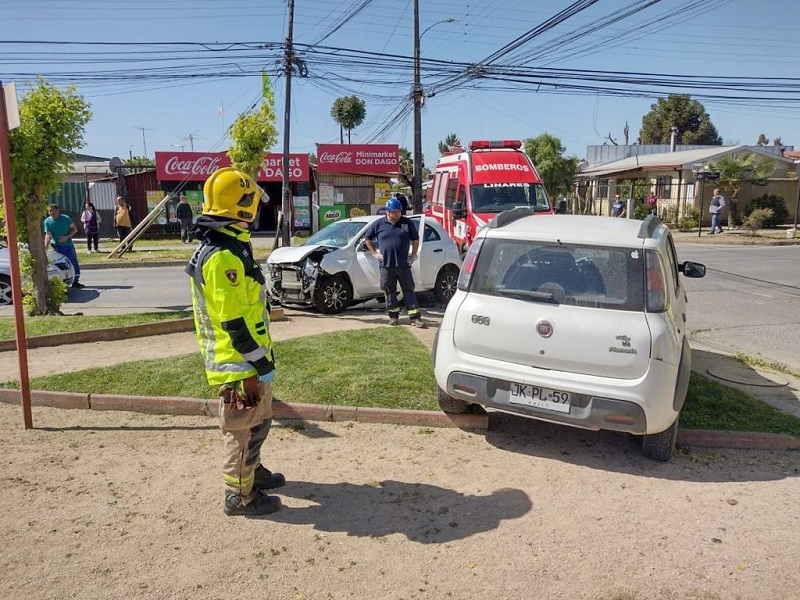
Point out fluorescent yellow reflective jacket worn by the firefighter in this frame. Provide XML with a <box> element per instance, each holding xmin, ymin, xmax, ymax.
<box><xmin>186</xmin><ymin>226</ymin><xmax>275</xmax><ymax>385</ymax></box>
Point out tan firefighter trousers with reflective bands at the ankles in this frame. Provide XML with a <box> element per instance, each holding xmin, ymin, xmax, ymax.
<box><xmin>219</xmin><ymin>382</ymin><xmax>272</xmax><ymax>504</ymax></box>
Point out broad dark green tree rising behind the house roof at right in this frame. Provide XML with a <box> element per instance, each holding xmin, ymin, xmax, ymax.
<box><xmin>639</xmin><ymin>94</ymin><xmax>722</xmax><ymax>146</ymax></box>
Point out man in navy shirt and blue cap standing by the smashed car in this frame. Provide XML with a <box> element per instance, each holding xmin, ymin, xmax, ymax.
<box><xmin>364</xmin><ymin>198</ymin><xmax>427</xmax><ymax>329</ymax></box>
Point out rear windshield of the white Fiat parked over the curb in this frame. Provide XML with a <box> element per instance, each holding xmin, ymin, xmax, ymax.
<box><xmin>469</xmin><ymin>238</ymin><xmax>645</xmax><ymax>311</ymax></box>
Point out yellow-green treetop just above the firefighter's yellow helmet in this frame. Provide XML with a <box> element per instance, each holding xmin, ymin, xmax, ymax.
<box><xmin>228</xmin><ymin>98</ymin><xmax>278</xmax><ymax>178</ymax></box>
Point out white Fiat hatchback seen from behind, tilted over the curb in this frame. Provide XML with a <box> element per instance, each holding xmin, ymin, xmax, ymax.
<box><xmin>433</xmin><ymin>209</ymin><xmax>706</xmax><ymax>460</ymax></box>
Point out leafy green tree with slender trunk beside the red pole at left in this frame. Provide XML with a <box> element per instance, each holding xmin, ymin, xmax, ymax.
<box><xmin>3</xmin><ymin>77</ymin><xmax>92</xmax><ymax>315</ymax></box>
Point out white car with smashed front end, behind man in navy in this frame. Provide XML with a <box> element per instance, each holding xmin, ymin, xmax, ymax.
<box><xmin>265</xmin><ymin>215</ymin><xmax>461</xmax><ymax>314</ymax></box>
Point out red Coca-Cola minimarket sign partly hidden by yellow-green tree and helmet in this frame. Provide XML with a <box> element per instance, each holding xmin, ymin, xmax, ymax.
<box><xmin>156</xmin><ymin>152</ymin><xmax>309</xmax><ymax>181</ymax></box>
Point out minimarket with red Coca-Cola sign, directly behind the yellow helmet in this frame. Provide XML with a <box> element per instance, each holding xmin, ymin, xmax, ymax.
<box><xmin>155</xmin><ymin>152</ymin><xmax>313</xmax><ymax>231</ymax></box>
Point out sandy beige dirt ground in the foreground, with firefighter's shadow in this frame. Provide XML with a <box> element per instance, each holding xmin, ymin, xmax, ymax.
<box><xmin>0</xmin><ymin>396</ymin><xmax>800</xmax><ymax>600</ymax></box>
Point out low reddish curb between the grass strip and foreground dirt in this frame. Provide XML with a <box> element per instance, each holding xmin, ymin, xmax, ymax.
<box><xmin>0</xmin><ymin>389</ymin><xmax>800</xmax><ymax>450</ymax></box>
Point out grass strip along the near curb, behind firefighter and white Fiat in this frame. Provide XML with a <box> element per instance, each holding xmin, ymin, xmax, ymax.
<box><xmin>4</xmin><ymin>328</ymin><xmax>800</xmax><ymax>436</ymax></box>
